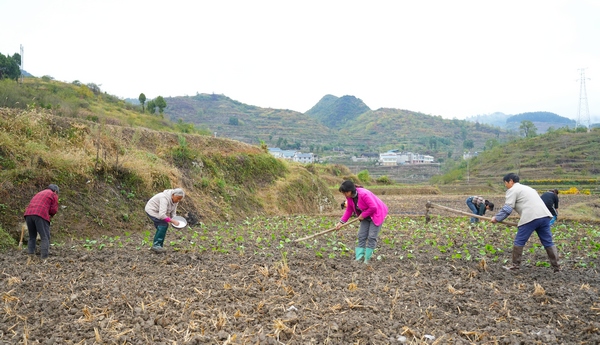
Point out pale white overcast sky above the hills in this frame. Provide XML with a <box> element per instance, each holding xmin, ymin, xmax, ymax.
<box><xmin>0</xmin><ymin>0</ymin><xmax>600</xmax><ymax>124</ymax></box>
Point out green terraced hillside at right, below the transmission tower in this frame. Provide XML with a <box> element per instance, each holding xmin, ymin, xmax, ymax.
<box><xmin>432</xmin><ymin>129</ymin><xmax>600</xmax><ymax>189</ymax></box>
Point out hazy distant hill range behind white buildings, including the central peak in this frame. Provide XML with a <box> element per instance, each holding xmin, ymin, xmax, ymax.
<box><xmin>165</xmin><ymin>94</ymin><xmax>508</xmax><ymax>161</ymax></box>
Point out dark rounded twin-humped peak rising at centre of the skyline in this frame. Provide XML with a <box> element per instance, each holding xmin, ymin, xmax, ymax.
<box><xmin>305</xmin><ymin>95</ymin><xmax>371</xmax><ymax>128</ymax></box>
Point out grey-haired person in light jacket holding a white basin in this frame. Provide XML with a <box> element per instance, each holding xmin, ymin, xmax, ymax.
<box><xmin>145</xmin><ymin>188</ymin><xmax>185</xmax><ymax>253</ymax></box>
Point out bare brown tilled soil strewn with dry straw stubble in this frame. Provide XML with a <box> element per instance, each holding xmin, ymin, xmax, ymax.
<box><xmin>0</xmin><ymin>195</ymin><xmax>600</xmax><ymax>344</ymax></box>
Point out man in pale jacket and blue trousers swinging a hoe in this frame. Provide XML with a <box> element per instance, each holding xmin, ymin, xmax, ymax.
<box><xmin>492</xmin><ymin>173</ymin><xmax>560</xmax><ymax>272</ymax></box>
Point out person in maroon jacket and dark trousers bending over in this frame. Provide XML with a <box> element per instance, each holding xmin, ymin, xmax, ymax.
<box><xmin>25</xmin><ymin>184</ymin><xmax>58</xmax><ymax>259</ymax></box>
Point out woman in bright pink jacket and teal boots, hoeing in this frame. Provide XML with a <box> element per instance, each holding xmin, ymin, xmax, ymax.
<box><xmin>335</xmin><ymin>181</ymin><xmax>388</xmax><ymax>263</ymax></box>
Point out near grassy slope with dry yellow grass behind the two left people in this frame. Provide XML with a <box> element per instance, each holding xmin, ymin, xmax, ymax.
<box><xmin>0</xmin><ymin>79</ymin><xmax>341</xmax><ymax>246</ymax></box>
